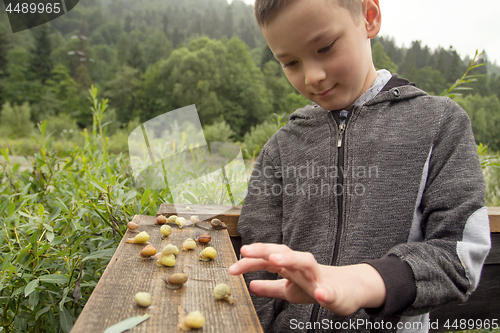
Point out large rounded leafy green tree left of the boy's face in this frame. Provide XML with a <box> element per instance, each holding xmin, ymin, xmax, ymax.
<box><xmin>136</xmin><ymin>37</ymin><xmax>271</xmax><ymax>136</ymax></box>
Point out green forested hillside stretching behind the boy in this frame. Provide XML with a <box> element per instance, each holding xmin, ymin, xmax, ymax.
<box><xmin>0</xmin><ymin>0</ymin><xmax>500</xmax><ymax>155</ymax></box>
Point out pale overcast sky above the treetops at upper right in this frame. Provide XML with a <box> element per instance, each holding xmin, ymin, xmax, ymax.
<box><xmin>234</xmin><ymin>0</ymin><xmax>500</xmax><ymax>65</ymax></box>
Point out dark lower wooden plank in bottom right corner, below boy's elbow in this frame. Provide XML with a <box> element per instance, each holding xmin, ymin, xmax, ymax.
<box><xmin>431</xmin><ymin>265</ymin><xmax>500</xmax><ymax>332</ymax></box>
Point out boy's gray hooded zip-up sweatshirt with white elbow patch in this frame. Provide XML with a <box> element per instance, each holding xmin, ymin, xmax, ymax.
<box><xmin>238</xmin><ymin>77</ymin><xmax>491</xmax><ymax>333</ymax></box>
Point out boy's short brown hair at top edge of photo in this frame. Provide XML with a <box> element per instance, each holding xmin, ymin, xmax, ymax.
<box><xmin>253</xmin><ymin>0</ymin><xmax>363</xmax><ymax>27</ymax></box>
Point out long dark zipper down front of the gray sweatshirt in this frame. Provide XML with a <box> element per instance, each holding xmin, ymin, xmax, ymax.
<box><xmin>307</xmin><ymin>110</ymin><xmax>349</xmax><ymax>333</ymax></box>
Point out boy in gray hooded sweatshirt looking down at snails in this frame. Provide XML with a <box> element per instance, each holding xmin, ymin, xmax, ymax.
<box><xmin>229</xmin><ymin>0</ymin><xmax>490</xmax><ymax>332</ymax></box>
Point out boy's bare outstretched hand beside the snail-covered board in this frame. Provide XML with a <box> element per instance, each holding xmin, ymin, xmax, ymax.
<box><xmin>229</xmin><ymin>243</ymin><xmax>386</xmax><ymax>316</ymax></box>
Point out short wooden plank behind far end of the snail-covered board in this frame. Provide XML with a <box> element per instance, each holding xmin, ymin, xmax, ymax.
<box><xmin>156</xmin><ymin>204</ymin><xmax>241</xmax><ymax>237</ymax></box>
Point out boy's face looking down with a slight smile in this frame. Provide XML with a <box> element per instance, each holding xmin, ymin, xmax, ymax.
<box><xmin>261</xmin><ymin>0</ymin><xmax>380</xmax><ymax>110</ymax></box>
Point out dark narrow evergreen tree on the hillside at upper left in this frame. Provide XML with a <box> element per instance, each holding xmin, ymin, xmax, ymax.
<box><xmin>28</xmin><ymin>24</ymin><xmax>52</xmax><ymax>82</ymax></box>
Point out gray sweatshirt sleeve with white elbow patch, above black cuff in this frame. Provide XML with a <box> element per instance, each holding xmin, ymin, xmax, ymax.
<box><xmin>378</xmin><ymin>99</ymin><xmax>491</xmax><ymax>315</ymax></box>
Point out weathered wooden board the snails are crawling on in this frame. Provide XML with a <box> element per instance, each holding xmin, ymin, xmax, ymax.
<box><xmin>71</xmin><ymin>215</ymin><xmax>262</xmax><ymax>333</ymax></box>
